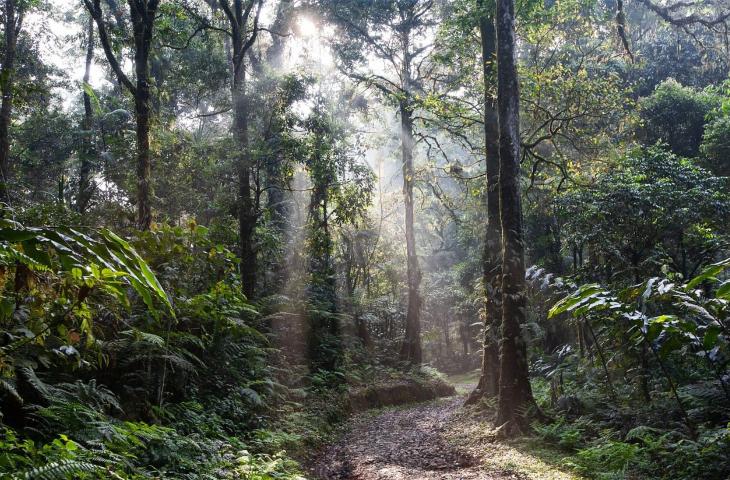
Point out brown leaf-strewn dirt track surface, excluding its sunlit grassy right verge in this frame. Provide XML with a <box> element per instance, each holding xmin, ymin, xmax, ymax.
<box><xmin>312</xmin><ymin>397</ymin><xmax>510</xmax><ymax>480</ymax></box>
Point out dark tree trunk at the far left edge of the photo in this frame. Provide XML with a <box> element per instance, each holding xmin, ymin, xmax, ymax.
<box><xmin>0</xmin><ymin>0</ymin><xmax>22</xmax><ymax>203</ymax></box>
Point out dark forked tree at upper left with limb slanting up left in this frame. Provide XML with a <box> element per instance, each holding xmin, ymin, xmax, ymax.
<box><xmin>84</xmin><ymin>0</ymin><xmax>160</xmax><ymax>230</ymax></box>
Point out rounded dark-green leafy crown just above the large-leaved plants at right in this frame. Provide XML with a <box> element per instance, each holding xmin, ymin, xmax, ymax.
<box><xmin>558</xmin><ymin>147</ymin><xmax>730</xmax><ymax>282</ymax></box>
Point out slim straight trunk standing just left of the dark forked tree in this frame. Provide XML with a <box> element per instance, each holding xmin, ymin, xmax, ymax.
<box><xmin>76</xmin><ymin>17</ymin><xmax>94</xmax><ymax>213</ymax></box>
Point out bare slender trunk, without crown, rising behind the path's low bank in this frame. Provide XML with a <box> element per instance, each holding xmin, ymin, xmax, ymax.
<box><xmin>400</xmin><ymin>100</ymin><xmax>423</xmax><ymax>365</ymax></box>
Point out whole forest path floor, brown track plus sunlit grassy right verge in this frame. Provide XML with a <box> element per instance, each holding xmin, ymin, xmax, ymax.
<box><xmin>309</xmin><ymin>375</ymin><xmax>578</xmax><ymax>480</ymax></box>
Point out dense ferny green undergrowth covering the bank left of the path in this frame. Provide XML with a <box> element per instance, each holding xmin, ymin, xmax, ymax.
<box><xmin>0</xmin><ymin>223</ymin><xmax>446</xmax><ymax>480</ymax></box>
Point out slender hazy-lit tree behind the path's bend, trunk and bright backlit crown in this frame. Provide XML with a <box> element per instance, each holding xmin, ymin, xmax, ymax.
<box><xmin>320</xmin><ymin>0</ymin><xmax>437</xmax><ymax>364</ymax></box>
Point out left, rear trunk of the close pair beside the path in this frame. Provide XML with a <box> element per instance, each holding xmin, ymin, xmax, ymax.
<box><xmin>466</xmin><ymin>0</ymin><xmax>502</xmax><ymax>404</ymax></box>
